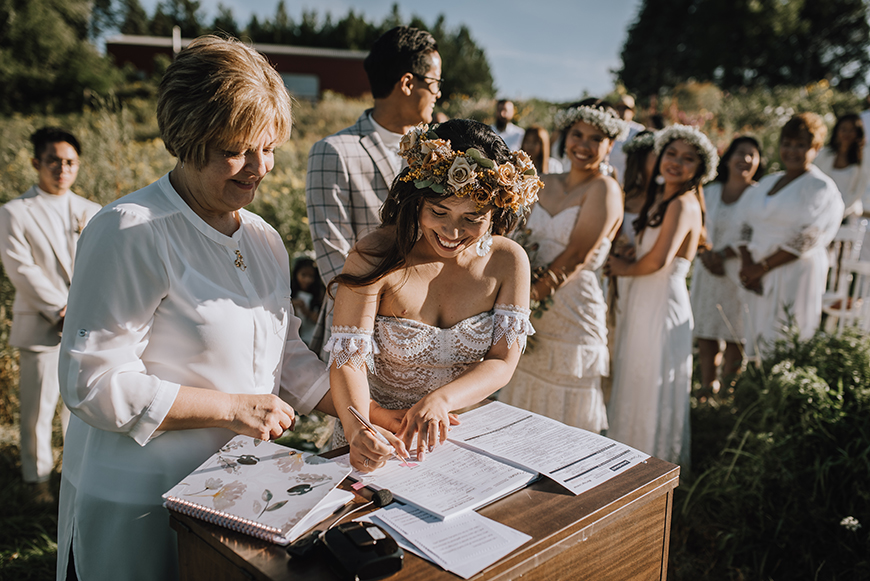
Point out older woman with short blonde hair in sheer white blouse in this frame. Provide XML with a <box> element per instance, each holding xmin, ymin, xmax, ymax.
<box><xmin>57</xmin><ymin>37</ymin><xmax>330</xmax><ymax>581</ymax></box>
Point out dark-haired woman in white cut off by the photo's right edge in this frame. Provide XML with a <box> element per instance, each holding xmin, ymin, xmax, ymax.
<box><xmin>813</xmin><ymin>113</ymin><xmax>870</xmax><ymax>220</ymax></box>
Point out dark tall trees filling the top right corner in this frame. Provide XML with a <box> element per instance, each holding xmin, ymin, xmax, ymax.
<box><xmin>617</xmin><ymin>0</ymin><xmax>870</xmax><ymax>94</ymax></box>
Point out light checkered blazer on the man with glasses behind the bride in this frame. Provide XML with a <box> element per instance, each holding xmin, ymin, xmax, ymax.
<box><xmin>305</xmin><ymin>109</ymin><xmax>397</xmax><ymax>355</ymax></box>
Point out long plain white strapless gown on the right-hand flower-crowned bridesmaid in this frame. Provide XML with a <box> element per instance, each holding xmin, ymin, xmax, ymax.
<box><xmin>607</xmin><ymin>227</ymin><xmax>694</xmax><ymax>469</ymax></box>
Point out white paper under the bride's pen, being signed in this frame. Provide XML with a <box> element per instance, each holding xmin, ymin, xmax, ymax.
<box><xmin>338</xmin><ymin>441</ymin><xmax>537</xmax><ymax>519</ymax></box>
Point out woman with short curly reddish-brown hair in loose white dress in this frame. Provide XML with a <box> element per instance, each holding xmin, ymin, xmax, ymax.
<box><xmin>740</xmin><ymin>113</ymin><xmax>845</xmax><ymax>355</ymax></box>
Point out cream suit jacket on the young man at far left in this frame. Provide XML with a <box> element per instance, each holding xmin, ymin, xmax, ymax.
<box><xmin>0</xmin><ymin>186</ymin><xmax>100</xmax><ymax>350</ymax></box>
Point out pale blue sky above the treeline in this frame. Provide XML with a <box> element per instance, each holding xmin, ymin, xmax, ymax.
<box><xmin>135</xmin><ymin>0</ymin><xmax>641</xmax><ymax>101</ymax></box>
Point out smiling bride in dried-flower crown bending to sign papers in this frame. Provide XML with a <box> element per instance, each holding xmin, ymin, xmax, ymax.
<box><xmin>326</xmin><ymin>119</ymin><xmax>541</xmax><ymax>472</ymax></box>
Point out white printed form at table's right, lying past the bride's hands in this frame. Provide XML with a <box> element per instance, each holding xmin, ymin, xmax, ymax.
<box><xmin>449</xmin><ymin>402</ymin><xmax>649</xmax><ymax>494</ymax></box>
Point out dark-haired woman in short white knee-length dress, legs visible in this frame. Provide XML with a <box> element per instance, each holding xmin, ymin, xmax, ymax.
<box><xmin>691</xmin><ymin>135</ymin><xmax>764</xmax><ymax>396</ymax></box>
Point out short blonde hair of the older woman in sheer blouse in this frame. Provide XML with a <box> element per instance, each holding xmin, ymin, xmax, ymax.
<box><xmin>157</xmin><ymin>36</ymin><xmax>292</xmax><ymax>168</ymax></box>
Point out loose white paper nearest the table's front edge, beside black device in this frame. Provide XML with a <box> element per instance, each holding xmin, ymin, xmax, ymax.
<box><xmin>367</xmin><ymin>504</ymin><xmax>532</xmax><ymax>579</ymax></box>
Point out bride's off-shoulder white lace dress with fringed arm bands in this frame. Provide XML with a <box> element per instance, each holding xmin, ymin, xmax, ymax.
<box><xmin>325</xmin><ymin>305</ymin><xmax>535</xmax><ymax>447</ymax></box>
